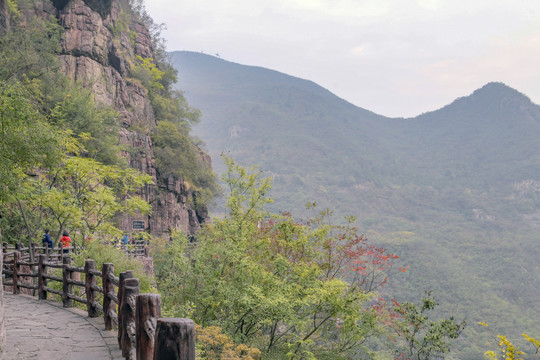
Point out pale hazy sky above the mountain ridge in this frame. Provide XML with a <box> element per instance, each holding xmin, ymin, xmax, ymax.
<box><xmin>145</xmin><ymin>0</ymin><xmax>540</xmax><ymax>117</ymax></box>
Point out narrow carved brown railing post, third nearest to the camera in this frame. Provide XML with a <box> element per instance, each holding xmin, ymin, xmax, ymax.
<box><xmin>119</xmin><ymin>279</ymin><xmax>139</xmax><ymax>360</ymax></box>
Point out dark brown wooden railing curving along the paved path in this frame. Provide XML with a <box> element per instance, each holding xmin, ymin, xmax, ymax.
<box><xmin>2</xmin><ymin>246</ymin><xmax>195</xmax><ymax>360</ymax></box>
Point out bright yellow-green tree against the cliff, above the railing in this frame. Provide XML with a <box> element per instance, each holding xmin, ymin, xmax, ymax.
<box><xmin>6</xmin><ymin>128</ymin><xmax>152</xmax><ymax>249</ymax></box>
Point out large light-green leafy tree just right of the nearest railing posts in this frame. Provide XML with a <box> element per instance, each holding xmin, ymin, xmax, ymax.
<box><xmin>156</xmin><ymin>158</ymin><xmax>402</xmax><ymax>359</ymax></box>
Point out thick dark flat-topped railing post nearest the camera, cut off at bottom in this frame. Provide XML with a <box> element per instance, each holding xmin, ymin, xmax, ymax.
<box><xmin>154</xmin><ymin>318</ymin><xmax>195</xmax><ymax>360</ymax></box>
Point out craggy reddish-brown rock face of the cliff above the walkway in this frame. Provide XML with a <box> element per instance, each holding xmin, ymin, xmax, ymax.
<box><xmin>21</xmin><ymin>0</ymin><xmax>206</xmax><ymax>236</ymax></box>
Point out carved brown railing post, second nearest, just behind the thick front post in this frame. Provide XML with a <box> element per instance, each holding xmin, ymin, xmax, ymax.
<box><xmin>135</xmin><ymin>294</ymin><xmax>161</xmax><ymax>360</ymax></box>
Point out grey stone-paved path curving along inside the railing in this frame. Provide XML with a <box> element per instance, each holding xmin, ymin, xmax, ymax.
<box><xmin>0</xmin><ymin>293</ymin><xmax>123</xmax><ymax>360</ymax></box>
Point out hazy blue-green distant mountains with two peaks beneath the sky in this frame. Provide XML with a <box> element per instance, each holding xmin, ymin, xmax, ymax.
<box><xmin>171</xmin><ymin>52</ymin><xmax>540</xmax><ymax>359</ymax></box>
